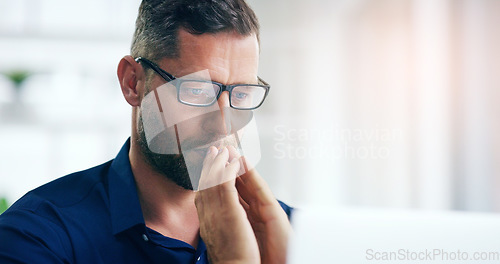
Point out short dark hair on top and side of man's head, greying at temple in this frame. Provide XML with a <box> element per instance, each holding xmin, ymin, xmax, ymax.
<box><xmin>131</xmin><ymin>0</ymin><xmax>259</xmax><ymax>60</ymax></box>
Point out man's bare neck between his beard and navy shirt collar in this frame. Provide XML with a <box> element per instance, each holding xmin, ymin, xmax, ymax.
<box><xmin>129</xmin><ymin>136</ymin><xmax>199</xmax><ymax>247</ymax></box>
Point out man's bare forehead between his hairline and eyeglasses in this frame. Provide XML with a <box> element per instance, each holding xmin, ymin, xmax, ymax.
<box><xmin>161</xmin><ymin>29</ymin><xmax>259</xmax><ymax>84</ymax></box>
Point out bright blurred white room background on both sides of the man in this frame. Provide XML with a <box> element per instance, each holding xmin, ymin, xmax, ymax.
<box><xmin>0</xmin><ymin>0</ymin><xmax>500</xmax><ymax>211</ymax></box>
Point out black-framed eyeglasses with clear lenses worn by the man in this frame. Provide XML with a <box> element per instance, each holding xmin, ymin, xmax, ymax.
<box><xmin>135</xmin><ymin>57</ymin><xmax>271</xmax><ymax>110</ymax></box>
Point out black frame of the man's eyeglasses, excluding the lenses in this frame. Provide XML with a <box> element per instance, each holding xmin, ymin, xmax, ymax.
<box><xmin>135</xmin><ymin>57</ymin><xmax>271</xmax><ymax>110</ymax></box>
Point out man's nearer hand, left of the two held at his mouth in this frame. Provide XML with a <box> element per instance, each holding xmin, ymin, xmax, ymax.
<box><xmin>195</xmin><ymin>147</ymin><xmax>260</xmax><ymax>264</ymax></box>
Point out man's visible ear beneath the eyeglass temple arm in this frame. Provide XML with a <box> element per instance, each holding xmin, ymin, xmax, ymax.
<box><xmin>117</xmin><ymin>55</ymin><xmax>144</xmax><ymax>106</ymax></box>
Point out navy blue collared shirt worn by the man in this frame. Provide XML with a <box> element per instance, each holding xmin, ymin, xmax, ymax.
<box><xmin>0</xmin><ymin>141</ymin><xmax>291</xmax><ymax>264</ymax></box>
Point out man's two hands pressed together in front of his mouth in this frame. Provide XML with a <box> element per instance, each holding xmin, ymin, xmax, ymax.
<box><xmin>195</xmin><ymin>146</ymin><xmax>291</xmax><ymax>263</ymax></box>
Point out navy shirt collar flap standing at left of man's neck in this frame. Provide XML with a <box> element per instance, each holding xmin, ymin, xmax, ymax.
<box><xmin>108</xmin><ymin>138</ymin><xmax>145</xmax><ymax>235</ymax></box>
